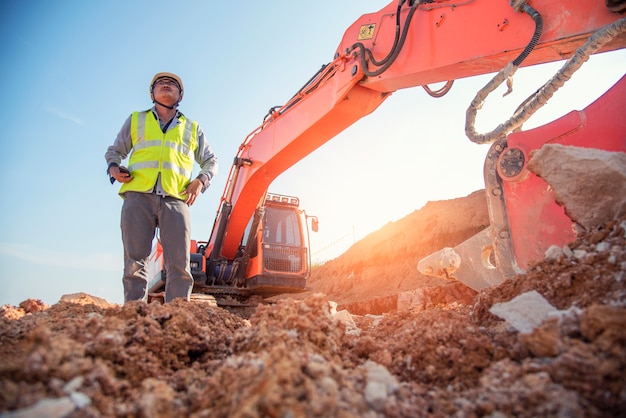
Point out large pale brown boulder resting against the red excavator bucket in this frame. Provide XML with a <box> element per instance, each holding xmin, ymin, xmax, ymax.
<box><xmin>528</xmin><ymin>144</ymin><xmax>626</xmax><ymax>230</ymax></box>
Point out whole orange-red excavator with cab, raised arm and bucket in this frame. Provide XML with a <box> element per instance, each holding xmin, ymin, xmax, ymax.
<box><xmin>150</xmin><ymin>0</ymin><xmax>626</xmax><ymax>306</ymax></box>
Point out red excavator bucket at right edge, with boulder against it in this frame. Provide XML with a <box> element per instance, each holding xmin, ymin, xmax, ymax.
<box><xmin>418</xmin><ymin>76</ymin><xmax>626</xmax><ymax>291</ymax></box>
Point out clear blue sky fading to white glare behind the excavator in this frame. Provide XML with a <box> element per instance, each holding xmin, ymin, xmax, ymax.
<box><xmin>0</xmin><ymin>0</ymin><xmax>626</xmax><ymax>305</ymax></box>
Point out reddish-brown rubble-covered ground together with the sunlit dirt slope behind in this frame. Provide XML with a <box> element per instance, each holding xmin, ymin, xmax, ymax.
<box><xmin>0</xmin><ymin>193</ymin><xmax>626</xmax><ymax>418</ymax></box>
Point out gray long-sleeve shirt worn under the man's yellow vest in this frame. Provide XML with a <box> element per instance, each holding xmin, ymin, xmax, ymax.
<box><xmin>104</xmin><ymin>107</ymin><xmax>218</xmax><ymax>194</ymax></box>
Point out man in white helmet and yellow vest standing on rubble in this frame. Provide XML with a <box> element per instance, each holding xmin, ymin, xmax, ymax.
<box><xmin>105</xmin><ymin>73</ymin><xmax>217</xmax><ymax>302</ymax></box>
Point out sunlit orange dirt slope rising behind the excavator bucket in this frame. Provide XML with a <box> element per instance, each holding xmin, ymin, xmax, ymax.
<box><xmin>300</xmin><ymin>190</ymin><xmax>489</xmax><ymax>314</ymax></box>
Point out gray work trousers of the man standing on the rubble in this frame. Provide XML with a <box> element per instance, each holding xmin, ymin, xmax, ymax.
<box><xmin>121</xmin><ymin>192</ymin><xmax>193</xmax><ymax>302</ymax></box>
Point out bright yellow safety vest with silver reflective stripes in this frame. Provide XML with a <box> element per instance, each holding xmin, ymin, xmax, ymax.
<box><xmin>120</xmin><ymin>110</ymin><xmax>198</xmax><ymax>200</ymax></box>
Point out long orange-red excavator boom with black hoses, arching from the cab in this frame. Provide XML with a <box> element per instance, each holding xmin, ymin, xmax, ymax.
<box><xmin>208</xmin><ymin>0</ymin><xmax>626</xmax><ymax>280</ymax></box>
